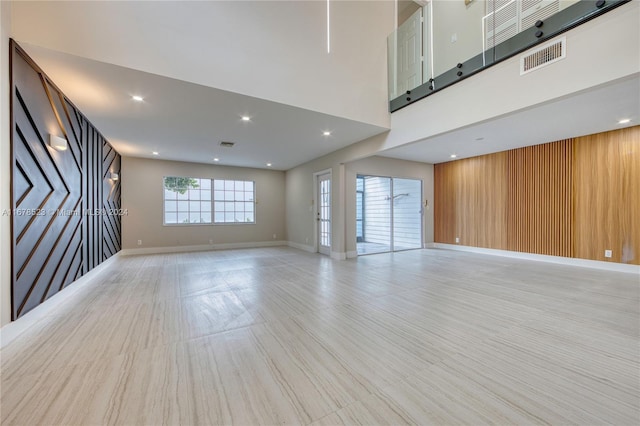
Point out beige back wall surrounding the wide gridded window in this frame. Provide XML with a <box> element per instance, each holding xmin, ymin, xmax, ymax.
<box><xmin>122</xmin><ymin>157</ymin><xmax>286</xmax><ymax>250</ymax></box>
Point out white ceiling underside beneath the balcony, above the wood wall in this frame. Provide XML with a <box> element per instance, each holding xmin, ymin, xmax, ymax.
<box><xmin>377</xmin><ymin>74</ymin><xmax>640</xmax><ymax>164</ymax></box>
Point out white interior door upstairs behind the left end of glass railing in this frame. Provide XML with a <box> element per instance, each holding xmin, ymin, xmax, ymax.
<box><xmin>397</xmin><ymin>8</ymin><xmax>422</xmax><ymax>94</ymax></box>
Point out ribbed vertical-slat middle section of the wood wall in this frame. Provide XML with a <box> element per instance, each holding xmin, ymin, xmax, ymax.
<box><xmin>507</xmin><ymin>140</ymin><xmax>573</xmax><ymax>257</ymax></box>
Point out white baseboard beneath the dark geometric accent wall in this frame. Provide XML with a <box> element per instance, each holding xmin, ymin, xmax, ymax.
<box><xmin>0</xmin><ymin>253</ymin><xmax>121</xmax><ymax>349</ymax></box>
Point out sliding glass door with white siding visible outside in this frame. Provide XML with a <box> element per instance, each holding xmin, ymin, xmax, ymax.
<box><xmin>356</xmin><ymin>175</ymin><xmax>423</xmax><ymax>255</ymax></box>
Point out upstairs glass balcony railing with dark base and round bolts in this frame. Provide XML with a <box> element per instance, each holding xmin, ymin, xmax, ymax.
<box><xmin>387</xmin><ymin>0</ymin><xmax>630</xmax><ymax>112</ymax></box>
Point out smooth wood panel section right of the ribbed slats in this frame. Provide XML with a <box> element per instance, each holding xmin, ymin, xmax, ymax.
<box><xmin>574</xmin><ymin>126</ymin><xmax>640</xmax><ymax>265</ymax></box>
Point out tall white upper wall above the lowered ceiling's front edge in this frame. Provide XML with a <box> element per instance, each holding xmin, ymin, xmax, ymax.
<box><xmin>13</xmin><ymin>1</ymin><xmax>395</xmax><ymax>127</ymax></box>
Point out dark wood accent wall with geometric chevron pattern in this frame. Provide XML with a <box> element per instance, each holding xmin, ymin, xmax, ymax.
<box><xmin>11</xmin><ymin>41</ymin><xmax>121</xmax><ymax>319</ymax></box>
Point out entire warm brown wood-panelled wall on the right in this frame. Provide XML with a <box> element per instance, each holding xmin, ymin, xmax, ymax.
<box><xmin>434</xmin><ymin>126</ymin><xmax>640</xmax><ymax>264</ymax></box>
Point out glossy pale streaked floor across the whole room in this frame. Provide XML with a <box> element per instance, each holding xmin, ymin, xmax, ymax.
<box><xmin>0</xmin><ymin>248</ymin><xmax>640</xmax><ymax>425</ymax></box>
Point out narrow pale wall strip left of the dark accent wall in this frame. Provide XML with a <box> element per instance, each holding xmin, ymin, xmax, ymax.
<box><xmin>0</xmin><ymin>1</ymin><xmax>11</xmax><ymax>326</ymax></box>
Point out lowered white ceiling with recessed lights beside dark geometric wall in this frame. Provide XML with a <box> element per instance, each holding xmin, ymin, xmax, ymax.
<box><xmin>20</xmin><ymin>43</ymin><xmax>388</xmax><ymax>170</ymax></box>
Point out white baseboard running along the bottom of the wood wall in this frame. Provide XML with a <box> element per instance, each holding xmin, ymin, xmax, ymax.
<box><xmin>431</xmin><ymin>243</ymin><xmax>640</xmax><ymax>275</ymax></box>
